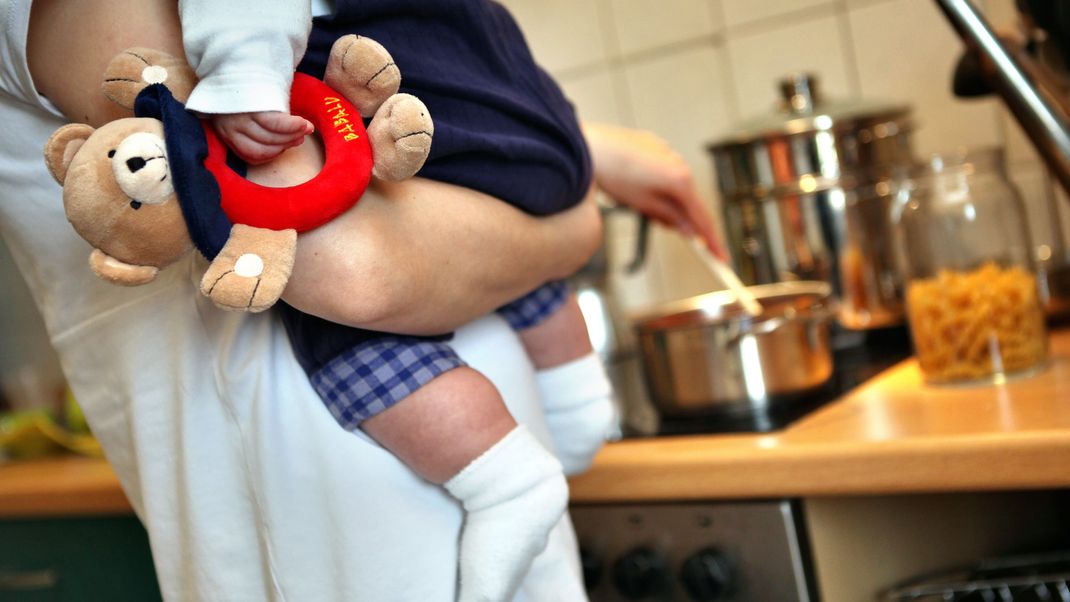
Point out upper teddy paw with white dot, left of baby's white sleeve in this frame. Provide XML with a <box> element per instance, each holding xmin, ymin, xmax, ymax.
<box><xmin>104</xmin><ymin>48</ymin><xmax>197</xmax><ymax>110</ymax></box>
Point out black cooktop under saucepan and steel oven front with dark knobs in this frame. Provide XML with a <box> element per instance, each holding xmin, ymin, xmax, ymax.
<box><xmin>570</xmin><ymin>328</ymin><xmax>912</xmax><ymax>602</ymax></box>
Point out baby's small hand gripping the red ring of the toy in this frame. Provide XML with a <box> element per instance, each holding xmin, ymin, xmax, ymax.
<box><xmin>211</xmin><ymin>111</ymin><xmax>315</xmax><ymax>165</ymax></box>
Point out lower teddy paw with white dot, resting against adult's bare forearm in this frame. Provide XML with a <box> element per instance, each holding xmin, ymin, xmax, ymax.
<box><xmin>201</xmin><ymin>253</ymin><xmax>286</xmax><ymax>313</ymax></box>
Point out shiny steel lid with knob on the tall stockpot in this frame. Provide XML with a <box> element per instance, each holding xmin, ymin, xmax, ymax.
<box><xmin>709</xmin><ymin>73</ymin><xmax>911</xmax><ymax>150</ymax></box>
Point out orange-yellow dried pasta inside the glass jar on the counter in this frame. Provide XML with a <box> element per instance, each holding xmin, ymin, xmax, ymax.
<box><xmin>906</xmin><ymin>262</ymin><xmax>1048</xmax><ymax>382</ymax></box>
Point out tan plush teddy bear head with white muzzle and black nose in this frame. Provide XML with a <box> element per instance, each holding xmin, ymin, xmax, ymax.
<box><xmin>45</xmin><ymin>118</ymin><xmax>193</xmax><ymax>285</ymax></box>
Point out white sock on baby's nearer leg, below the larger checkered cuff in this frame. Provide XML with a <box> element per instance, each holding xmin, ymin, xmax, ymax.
<box><xmin>444</xmin><ymin>426</ymin><xmax>568</xmax><ymax>602</ymax></box>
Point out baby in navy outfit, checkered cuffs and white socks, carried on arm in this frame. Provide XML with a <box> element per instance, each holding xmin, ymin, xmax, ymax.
<box><xmin>179</xmin><ymin>0</ymin><xmax>614</xmax><ymax>601</ymax></box>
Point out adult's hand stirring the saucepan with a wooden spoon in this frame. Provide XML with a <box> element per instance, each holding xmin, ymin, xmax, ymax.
<box><xmin>583</xmin><ymin>123</ymin><xmax>728</xmax><ymax>260</ymax></box>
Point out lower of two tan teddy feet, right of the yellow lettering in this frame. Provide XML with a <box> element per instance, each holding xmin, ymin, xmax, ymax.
<box><xmin>368</xmin><ymin>94</ymin><xmax>434</xmax><ymax>182</ymax></box>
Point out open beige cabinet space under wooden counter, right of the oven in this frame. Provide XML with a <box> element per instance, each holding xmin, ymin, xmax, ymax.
<box><xmin>803</xmin><ymin>490</ymin><xmax>1070</xmax><ymax>602</ymax></box>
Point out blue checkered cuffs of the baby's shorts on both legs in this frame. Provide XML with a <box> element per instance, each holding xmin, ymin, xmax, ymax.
<box><xmin>310</xmin><ymin>281</ymin><xmax>568</xmax><ymax>430</ymax></box>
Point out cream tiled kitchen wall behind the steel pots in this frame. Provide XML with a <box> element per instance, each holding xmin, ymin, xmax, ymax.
<box><xmin>504</xmin><ymin>0</ymin><xmax>1070</xmax><ymax>316</ymax></box>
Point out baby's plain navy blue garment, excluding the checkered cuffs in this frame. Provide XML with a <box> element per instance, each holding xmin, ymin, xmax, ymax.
<box><xmin>278</xmin><ymin>0</ymin><xmax>592</xmax><ymax>374</ymax></box>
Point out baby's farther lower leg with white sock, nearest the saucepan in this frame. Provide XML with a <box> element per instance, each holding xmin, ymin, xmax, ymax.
<box><xmin>503</xmin><ymin>284</ymin><xmax>618</xmax><ymax>475</ymax></box>
